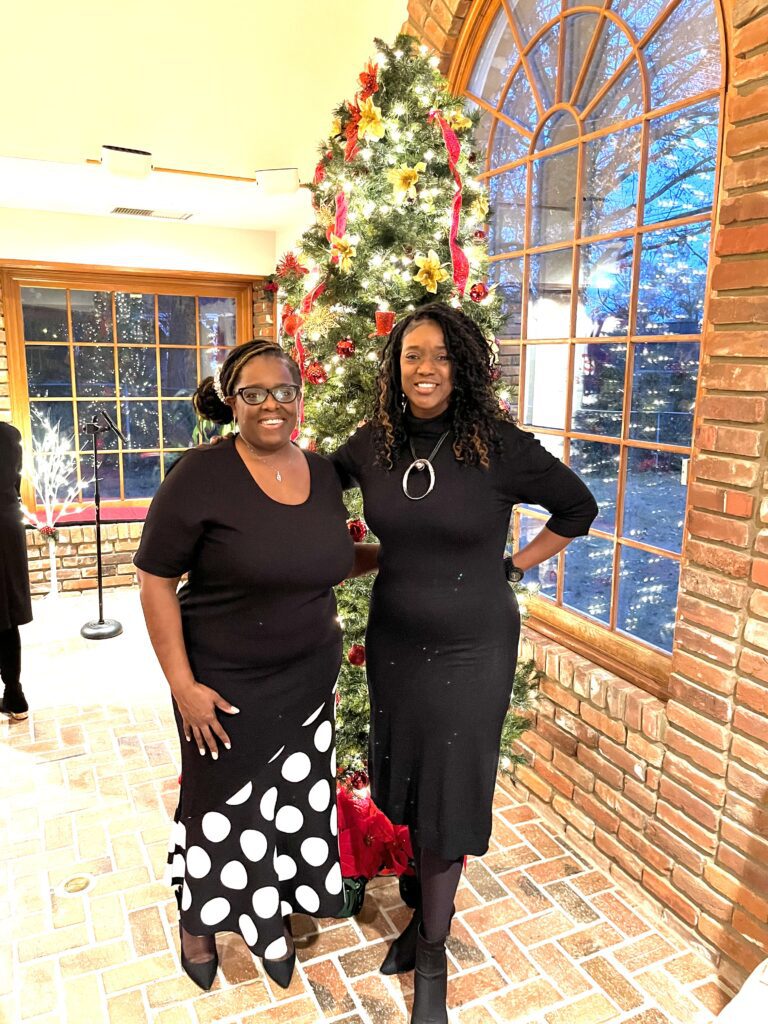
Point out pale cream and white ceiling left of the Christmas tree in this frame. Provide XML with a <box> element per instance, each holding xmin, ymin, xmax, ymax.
<box><xmin>0</xmin><ymin>0</ymin><xmax>408</xmax><ymax>230</ymax></box>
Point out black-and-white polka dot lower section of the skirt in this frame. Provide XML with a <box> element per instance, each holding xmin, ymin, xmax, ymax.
<box><xmin>166</xmin><ymin>687</ymin><xmax>343</xmax><ymax>959</ymax></box>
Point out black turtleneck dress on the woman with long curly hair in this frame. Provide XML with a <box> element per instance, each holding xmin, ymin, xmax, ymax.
<box><xmin>333</xmin><ymin>414</ymin><xmax>597</xmax><ymax>860</ymax></box>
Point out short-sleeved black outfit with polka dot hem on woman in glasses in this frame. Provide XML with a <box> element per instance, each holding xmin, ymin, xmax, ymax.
<box><xmin>134</xmin><ymin>440</ymin><xmax>353</xmax><ymax>959</ymax></box>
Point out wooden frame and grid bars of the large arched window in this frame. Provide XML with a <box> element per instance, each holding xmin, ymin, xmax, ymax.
<box><xmin>449</xmin><ymin>0</ymin><xmax>727</xmax><ymax>699</ymax></box>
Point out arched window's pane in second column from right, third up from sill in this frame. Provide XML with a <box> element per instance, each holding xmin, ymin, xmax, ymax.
<box><xmin>571</xmin><ymin>342</ymin><xmax>627</xmax><ymax>437</ymax></box>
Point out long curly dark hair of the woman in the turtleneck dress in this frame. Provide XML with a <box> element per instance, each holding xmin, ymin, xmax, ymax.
<box><xmin>373</xmin><ymin>302</ymin><xmax>509</xmax><ymax>469</ymax></box>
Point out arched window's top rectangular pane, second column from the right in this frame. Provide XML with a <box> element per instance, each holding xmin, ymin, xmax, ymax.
<box><xmin>582</xmin><ymin>125</ymin><xmax>641</xmax><ymax>237</ymax></box>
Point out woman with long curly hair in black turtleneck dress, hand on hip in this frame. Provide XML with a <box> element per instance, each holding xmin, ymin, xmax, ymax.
<box><xmin>334</xmin><ymin>303</ymin><xmax>597</xmax><ymax>1024</ymax></box>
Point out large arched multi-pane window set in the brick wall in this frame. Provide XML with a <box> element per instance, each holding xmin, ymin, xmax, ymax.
<box><xmin>455</xmin><ymin>0</ymin><xmax>723</xmax><ymax>692</ymax></box>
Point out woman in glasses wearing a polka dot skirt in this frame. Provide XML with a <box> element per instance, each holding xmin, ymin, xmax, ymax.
<box><xmin>134</xmin><ymin>341</ymin><xmax>353</xmax><ymax>988</ymax></box>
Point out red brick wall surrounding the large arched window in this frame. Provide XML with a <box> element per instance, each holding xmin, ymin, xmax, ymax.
<box><xmin>409</xmin><ymin>0</ymin><xmax>768</xmax><ymax>986</ymax></box>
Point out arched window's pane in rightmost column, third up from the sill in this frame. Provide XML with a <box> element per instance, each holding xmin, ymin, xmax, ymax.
<box><xmin>630</xmin><ymin>341</ymin><xmax>698</xmax><ymax>445</ymax></box>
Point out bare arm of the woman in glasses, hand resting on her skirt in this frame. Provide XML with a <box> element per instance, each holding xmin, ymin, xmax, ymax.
<box><xmin>137</xmin><ymin>569</ymin><xmax>238</xmax><ymax>760</ymax></box>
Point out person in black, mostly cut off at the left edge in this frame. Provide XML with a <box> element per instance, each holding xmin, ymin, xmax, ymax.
<box><xmin>0</xmin><ymin>422</ymin><xmax>32</xmax><ymax>720</ymax></box>
